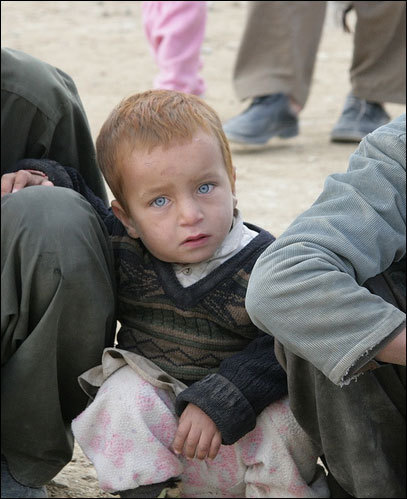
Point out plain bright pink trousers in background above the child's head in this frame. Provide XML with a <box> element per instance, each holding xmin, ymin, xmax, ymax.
<box><xmin>142</xmin><ymin>1</ymin><xmax>206</xmax><ymax>95</ymax></box>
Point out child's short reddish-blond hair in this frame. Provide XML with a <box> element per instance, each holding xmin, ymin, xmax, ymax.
<box><xmin>96</xmin><ymin>90</ymin><xmax>234</xmax><ymax>209</ymax></box>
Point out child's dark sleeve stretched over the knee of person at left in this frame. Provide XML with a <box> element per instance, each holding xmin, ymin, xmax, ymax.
<box><xmin>10</xmin><ymin>158</ymin><xmax>112</xmax><ymax>223</ymax></box>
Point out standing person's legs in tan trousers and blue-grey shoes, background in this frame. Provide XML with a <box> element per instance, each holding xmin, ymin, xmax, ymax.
<box><xmin>224</xmin><ymin>1</ymin><xmax>406</xmax><ymax>145</ymax></box>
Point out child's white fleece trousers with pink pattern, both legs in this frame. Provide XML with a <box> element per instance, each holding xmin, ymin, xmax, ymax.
<box><xmin>72</xmin><ymin>365</ymin><xmax>329</xmax><ymax>498</ymax></box>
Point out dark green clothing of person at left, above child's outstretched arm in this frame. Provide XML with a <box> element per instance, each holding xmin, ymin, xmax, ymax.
<box><xmin>1</xmin><ymin>48</ymin><xmax>107</xmax><ymax>204</ymax></box>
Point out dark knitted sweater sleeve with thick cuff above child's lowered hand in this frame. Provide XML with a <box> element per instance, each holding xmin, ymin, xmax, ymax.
<box><xmin>176</xmin><ymin>335</ymin><xmax>287</xmax><ymax>445</ymax></box>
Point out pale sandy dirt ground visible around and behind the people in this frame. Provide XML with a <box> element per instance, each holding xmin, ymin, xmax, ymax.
<box><xmin>1</xmin><ymin>1</ymin><xmax>404</xmax><ymax>497</ymax></box>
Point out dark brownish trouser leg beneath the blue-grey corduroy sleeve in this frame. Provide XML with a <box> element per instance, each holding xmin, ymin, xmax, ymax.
<box><xmin>278</xmin><ymin>344</ymin><xmax>406</xmax><ymax>498</ymax></box>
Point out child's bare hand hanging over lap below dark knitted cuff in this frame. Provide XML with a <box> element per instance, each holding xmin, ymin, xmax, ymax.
<box><xmin>172</xmin><ymin>404</ymin><xmax>222</xmax><ymax>459</ymax></box>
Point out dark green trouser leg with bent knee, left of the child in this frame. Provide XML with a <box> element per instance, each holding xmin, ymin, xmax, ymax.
<box><xmin>1</xmin><ymin>187</ymin><xmax>115</xmax><ymax>486</ymax></box>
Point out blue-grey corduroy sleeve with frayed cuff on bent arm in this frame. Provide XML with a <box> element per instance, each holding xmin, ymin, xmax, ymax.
<box><xmin>246</xmin><ymin>115</ymin><xmax>406</xmax><ymax>385</ymax></box>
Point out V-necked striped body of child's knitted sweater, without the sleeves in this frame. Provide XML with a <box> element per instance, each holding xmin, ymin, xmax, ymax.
<box><xmin>112</xmin><ymin>226</ymin><xmax>272</xmax><ymax>383</ymax></box>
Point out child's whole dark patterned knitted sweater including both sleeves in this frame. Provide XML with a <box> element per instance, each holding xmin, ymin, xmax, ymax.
<box><xmin>15</xmin><ymin>160</ymin><xmax>287</xmax><ymax>444</ymax></box>
